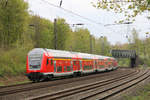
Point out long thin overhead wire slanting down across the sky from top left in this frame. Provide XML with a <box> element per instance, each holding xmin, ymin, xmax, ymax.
<box><xmin>41</xmin><ymin>0</ymin><xmax>103</xmax><ymax>25</ymax></box>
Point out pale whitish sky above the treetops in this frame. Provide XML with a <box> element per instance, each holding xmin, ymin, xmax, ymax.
<box><xmin>25</xmin><ymin>0</ymin><xmax>150</xmax><ymax>44</ymax></box>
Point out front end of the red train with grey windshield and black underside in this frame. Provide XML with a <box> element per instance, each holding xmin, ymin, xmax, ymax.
<box><xmin>26</xmin><ymin>48</ymin><xmax>44</xmax><ymax>82</ymax></box>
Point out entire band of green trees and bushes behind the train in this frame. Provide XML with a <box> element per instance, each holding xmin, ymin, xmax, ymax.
<box><xmin>0</xmin><ymin>0</ymin><xmax>150</xmax><ymax>78</ymax></box>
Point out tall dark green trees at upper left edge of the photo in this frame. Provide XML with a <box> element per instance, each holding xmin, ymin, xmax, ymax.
<box><xmin>0</xmin><ymin>0</ymin><xmax>29</xmax><ymax>47</ymax></box>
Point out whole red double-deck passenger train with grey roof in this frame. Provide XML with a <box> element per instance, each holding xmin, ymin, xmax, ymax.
<box><xmin>26</xmin><ymin>48</ymin><xmax>118</xmax><ymax>82</ymax></box>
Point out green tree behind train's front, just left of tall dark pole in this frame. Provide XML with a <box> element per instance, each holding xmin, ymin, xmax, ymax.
<box><xmin>30</xmin><ymin>16</ymin><xmax>54</xmax><ymax>49</ymax></box>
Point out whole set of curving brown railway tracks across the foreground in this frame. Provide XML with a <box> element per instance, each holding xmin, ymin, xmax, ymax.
<box><xmin>0</xmin><ymin>68</ymin><xmax>150</xmax><ymax>100</ymax></box>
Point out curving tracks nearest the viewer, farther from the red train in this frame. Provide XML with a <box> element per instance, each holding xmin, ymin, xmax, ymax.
<box><xmin>28</xmin><ymin>70</ymin><xmax>150</xmax><ymax>100</ymax></box>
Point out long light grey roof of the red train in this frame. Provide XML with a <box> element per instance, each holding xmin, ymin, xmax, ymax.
<box><xmin>29</xmin><ymin>48</ymin><xmax>114</xmax><ymax>59</ymax></box>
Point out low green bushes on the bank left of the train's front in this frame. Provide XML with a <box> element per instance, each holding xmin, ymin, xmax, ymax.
<box><xmin>0</xmin><ymin>48</ymin><xmax>29</xmax><ymax>76</ymax></box>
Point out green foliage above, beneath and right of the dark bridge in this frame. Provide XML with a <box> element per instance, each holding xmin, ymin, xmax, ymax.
<box><xmin>112</xmin><ymin>29</ymin><xmax>150</xmax><ymax>66</ymax></box>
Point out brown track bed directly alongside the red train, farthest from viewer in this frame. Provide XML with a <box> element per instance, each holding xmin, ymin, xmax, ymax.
<box><xmin>0</xmin><ymin>70</ymin><xmax>136</xmax><ymax>97</ymax></box>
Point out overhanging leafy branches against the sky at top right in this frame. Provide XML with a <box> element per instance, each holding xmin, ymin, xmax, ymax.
<box><xmin>93</xmin><ymin>0</ymin><xmax>150</xmax><ymax>23</ymax></box>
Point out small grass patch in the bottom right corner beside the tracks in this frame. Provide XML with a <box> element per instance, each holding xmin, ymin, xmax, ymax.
<box><xmin>126</xmin><ymin>84</ymin><xmax>150</xmax><ymax>100</ymax></box>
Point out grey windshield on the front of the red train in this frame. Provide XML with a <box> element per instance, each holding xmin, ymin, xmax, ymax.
<box><xmin>29</xmin><ymin>54</ymin><xmax>42</xmax><ymax>70</ymax></box>
